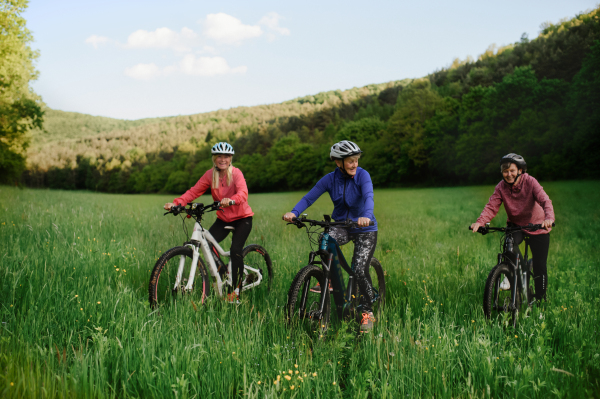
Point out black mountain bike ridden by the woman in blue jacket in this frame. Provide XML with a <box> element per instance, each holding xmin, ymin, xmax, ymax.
<box><xmin>286</xmin><ymin>215</ymin><xmax>385</xmax><ymax>332</ymax></box>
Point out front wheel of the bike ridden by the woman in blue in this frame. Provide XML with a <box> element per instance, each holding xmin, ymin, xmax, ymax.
<box><xmin>286</xmin><ymin>265</ymin><xmax>331</xmax><ymax>335</ymax></box>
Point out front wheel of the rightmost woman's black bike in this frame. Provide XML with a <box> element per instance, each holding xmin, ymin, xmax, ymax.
<box><xmin>483</xmin><ymin>263</ymin><xmax>521</xmax><ymax>327</ymax></box>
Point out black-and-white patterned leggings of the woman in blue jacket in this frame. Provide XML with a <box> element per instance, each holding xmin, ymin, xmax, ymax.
<box><xmin>329</xmin><ymin>227</ymin><xmax>377</xmax><ymax>313</ymax></box>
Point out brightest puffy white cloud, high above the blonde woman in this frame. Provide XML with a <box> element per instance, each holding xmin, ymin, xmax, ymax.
<box><xmin>204</xmin><ymin>12</ymin><xmax>263</xmax><ymax>44</ymax></box>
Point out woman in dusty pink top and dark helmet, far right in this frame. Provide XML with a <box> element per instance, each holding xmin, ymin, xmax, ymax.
<box><xmin>471</xmin><ymin>153</ymin><xmax>554</xmax><ymax>301</ymax></box>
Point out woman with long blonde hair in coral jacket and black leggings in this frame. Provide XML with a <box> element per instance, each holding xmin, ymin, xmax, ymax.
<box><xmin>165</xmin><ymin>143</ymin><xmax>254</xmax><ymax>303</ymax></box>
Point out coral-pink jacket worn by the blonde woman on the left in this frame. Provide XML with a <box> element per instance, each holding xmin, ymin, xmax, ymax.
<box><xmin>173</xmin><ymin>167</ymin><xmax>254</xmax><ymax>222</ymax></box>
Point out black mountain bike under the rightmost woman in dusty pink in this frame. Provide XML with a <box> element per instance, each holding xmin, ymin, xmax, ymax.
<box><xmin>469</xmin><ymin>223</ymin><xmax>554</xmax><ymax>327</ymax></box>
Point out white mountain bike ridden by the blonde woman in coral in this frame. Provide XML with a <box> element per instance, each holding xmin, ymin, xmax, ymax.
<box><xmin>148</xmin><ymin>201</ymin><xmax>273</xmax><ymax>308</ymax></box>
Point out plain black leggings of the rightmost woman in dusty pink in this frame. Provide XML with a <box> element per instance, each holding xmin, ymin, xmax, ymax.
<box><xmin>513</xmin><ymin>231</ymin><xmax>550</xmax><ymax>300</ymax></box>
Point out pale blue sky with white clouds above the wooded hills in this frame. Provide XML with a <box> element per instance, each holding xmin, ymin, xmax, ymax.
<box><xmin>24</xmin><ymin>0</ymin><xmax>597</xmax><ymax>119</ymax></box>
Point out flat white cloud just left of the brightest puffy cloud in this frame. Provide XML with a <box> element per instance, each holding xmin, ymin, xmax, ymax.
<box><xmin>125</xmin><ymin>27</ymin><xmax>198</xmax><ymax>51</ymax></box>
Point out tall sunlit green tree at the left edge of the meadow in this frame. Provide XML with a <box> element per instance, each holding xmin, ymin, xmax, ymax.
<box><xmin>0</xmin><ymin>0</ymin><xmax>43</xmax><ymax>183</ymax></box>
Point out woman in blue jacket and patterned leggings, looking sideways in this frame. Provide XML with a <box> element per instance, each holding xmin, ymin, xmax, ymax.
<box><xmin>283</xmin><ymin>140</ymin><xmax>377</xmax><ymax>332</ymax></box>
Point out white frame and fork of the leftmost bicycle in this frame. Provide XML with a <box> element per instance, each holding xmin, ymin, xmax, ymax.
<box><xmin>174</xmin><ymin>222</ymin><xmax>263</xmax><ymax>296</ymax></box>
